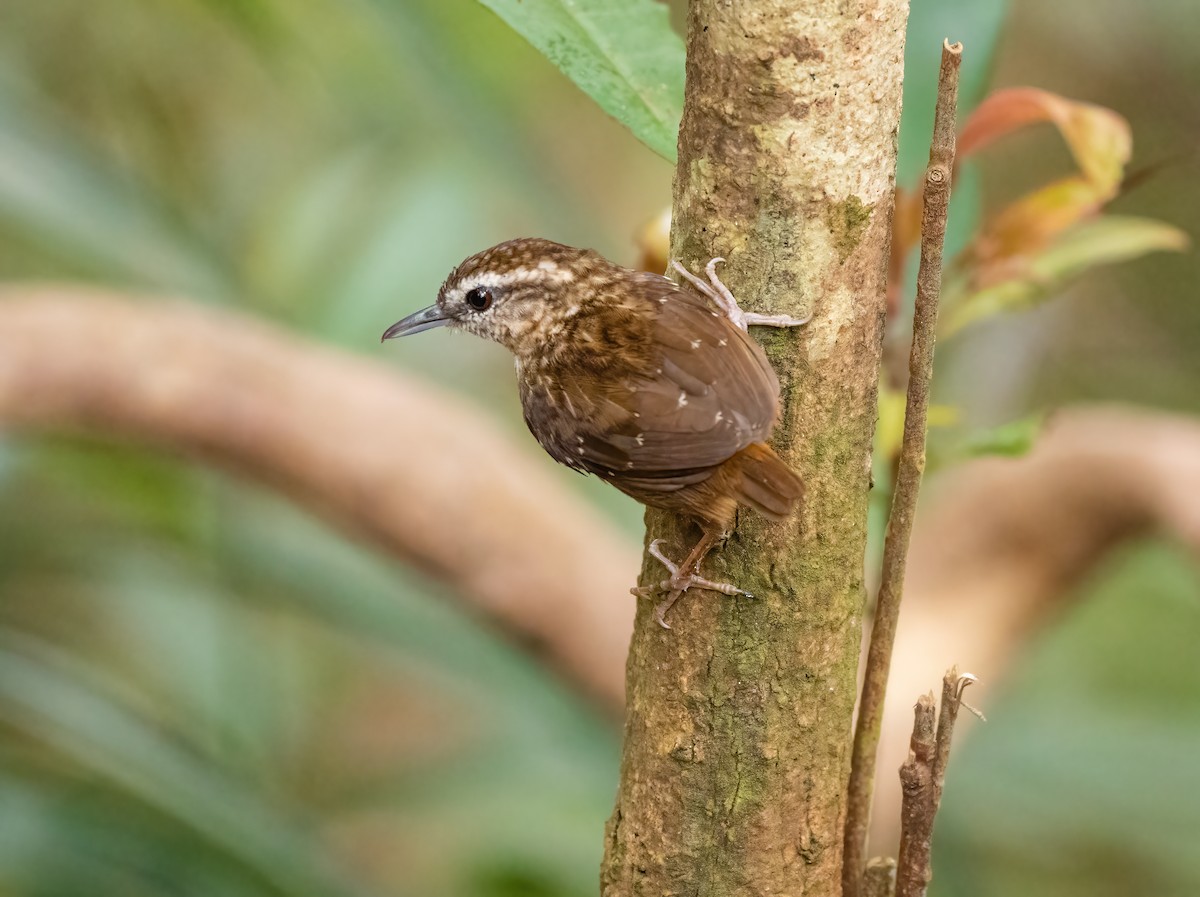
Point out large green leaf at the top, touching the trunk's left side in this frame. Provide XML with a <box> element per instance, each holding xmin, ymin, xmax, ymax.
<box><xmin>480</xmin><ymin>0</ymin><xmax>684</xmax><ymax>162</ymax></box>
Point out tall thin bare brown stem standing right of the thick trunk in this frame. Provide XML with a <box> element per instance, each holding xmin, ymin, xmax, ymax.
<box><xmin>842</xmin><ymin>42</ymin><xmax>962</xmax><ymax>897</ymax></box>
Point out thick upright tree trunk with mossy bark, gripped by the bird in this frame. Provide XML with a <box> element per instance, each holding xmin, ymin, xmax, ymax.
<box><xmin>601</xmin><ymin>0</ymin><xmax>907</xmax><ymax>897</ymax></box>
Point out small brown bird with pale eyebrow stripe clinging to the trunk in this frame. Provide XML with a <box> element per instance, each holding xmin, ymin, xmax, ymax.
<box><xmin>383</xmin><ymin>239</ymin><xmax>805</xmax><ymax>628</ymax></box>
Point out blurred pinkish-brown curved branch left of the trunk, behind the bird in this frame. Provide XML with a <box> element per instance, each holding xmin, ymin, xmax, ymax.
<box><xmin>0</xmin><ymin>287</ymin><xmax>638</xmax><ymax>714</ymax></box>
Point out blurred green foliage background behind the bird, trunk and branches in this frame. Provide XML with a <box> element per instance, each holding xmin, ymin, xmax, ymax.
<box><xmin>0</xmin><ymin>0</ymin><xmax>1200</xmax><ymax>897</ymax></box>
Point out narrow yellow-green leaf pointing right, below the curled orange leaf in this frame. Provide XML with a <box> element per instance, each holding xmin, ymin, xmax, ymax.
<box><xmin>940</xmin><ymin>215</ymin><xmax>1188</xmax><ymax>338</ymax></box>
